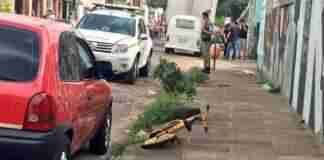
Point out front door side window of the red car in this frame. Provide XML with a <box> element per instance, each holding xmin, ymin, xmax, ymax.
<box><xmin>77</xmin><ymin>40</ymin><xmax>96</xmax><ymax>79</ymax></box>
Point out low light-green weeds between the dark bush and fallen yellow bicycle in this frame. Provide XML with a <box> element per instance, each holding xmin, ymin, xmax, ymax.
<box><xmin>129</xmin><ymin>93</ymin><xmax>181</xmax><ymax>144</ymax></box>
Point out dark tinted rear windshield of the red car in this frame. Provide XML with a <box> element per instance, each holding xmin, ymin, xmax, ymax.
<box><xmin>0</xmin><ymin>26</ymin><xmax>39</xmax><ymax>81</ymax></box>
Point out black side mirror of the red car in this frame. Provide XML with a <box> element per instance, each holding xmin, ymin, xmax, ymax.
<box><xmin>95</xmin><ymin>62</ymin><xmax>113</xmax><ymax>80</ymax></box>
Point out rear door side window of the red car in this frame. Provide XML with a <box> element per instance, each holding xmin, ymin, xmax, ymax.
<box><xmin>59</xmin><ymin>32</ymin><xmax>81</xmax><ymax>81</ymax></box>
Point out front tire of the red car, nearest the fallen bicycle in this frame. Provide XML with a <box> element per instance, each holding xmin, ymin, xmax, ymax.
<box><xmin>90</xmin><ymin>106</ymin><xmax>112</xmax><ymax>156</ymax></box>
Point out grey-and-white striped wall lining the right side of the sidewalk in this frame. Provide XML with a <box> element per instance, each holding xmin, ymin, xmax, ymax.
<box><xmin>250</xmin><ymin>0</ymin><xmax>324</xmax><ymax>138</ymax></box>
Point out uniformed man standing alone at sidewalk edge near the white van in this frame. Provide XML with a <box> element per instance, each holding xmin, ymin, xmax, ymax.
<box><xmin>201</xmin><ymin>12</ymin><xmax>213</xmax><ymax>74</ymax></box>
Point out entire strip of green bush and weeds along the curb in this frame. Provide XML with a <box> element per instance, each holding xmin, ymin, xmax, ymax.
<box><xmin>113</xmin><ymin>59</ymin><xmax>209</xmax><ymax>159</ymax></box>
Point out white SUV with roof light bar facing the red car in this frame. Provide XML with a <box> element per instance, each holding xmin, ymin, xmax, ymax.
<box><xmin>77</xmin><ymin>5</ymin><xmax>153</xmax><ymax>84</ymax></box>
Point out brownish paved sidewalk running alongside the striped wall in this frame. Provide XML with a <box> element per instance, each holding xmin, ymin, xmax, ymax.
<box><xmin>123</xmin><ymin>61</ymin><xmax>324</xmax><ymax>160</ymax></box>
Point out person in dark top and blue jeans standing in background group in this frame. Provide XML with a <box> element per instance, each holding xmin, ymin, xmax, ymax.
<box><xmin>226</xmin><ymin>19</ymin><xmax>241</xmax><ymax>60</ymax></box>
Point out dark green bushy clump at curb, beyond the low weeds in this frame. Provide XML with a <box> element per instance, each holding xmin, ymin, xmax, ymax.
<box><xmin>154</xmin><ymin>59</ymin><xmax>197</xmax><ymax>98</ymax></box>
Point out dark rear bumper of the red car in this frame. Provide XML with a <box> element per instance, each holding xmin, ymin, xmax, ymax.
<box><xmin>0</xmin><ymin>129</ymin><xmax>66</xmax><ymax>160</ymax></box>
